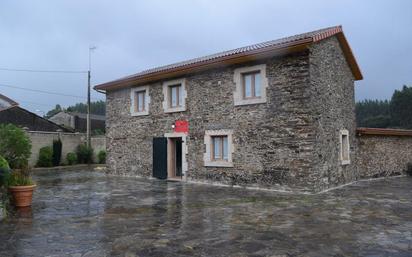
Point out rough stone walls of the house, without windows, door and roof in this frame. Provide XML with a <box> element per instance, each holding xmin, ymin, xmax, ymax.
<box><xmin>106</xmin><ymin>34</ymin><xmax>357</xmax><ymax>191</ymax></box>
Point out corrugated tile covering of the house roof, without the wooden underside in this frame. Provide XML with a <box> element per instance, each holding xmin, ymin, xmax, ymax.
<box><xmin>95</xmin><ymin>26</ymin><xmax>362</xmax><ymax>90</ymax></box>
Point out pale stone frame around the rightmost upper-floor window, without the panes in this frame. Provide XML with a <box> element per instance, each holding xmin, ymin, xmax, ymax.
<box><xmin>233</xmin><ymin>64</ymin><xmax>269</xmax><ymax>105</ymax></box>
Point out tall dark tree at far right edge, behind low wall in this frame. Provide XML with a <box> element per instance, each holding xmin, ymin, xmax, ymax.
<box><xmin>390</xmin><ymin>85</ymin><xmax>412</xmax><ymax>129</ymax></box>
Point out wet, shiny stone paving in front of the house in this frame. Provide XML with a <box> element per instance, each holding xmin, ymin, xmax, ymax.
<box><xmin>0</xmin><ymin>171</ymin><xmax>412</xmax><ymax>257</ymax></box>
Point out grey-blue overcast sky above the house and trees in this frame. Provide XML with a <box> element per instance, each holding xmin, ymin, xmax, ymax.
<box><xmin>0</xmin><ymin>0</ymin><xmax>412</xmax><ymax>113</ymax></box>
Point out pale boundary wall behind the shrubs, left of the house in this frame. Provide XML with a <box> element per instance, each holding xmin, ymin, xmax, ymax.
<box><xmin>26</xmin><ymin>131</ymin><xmax>106</xmax><ymax>167</ymax></box>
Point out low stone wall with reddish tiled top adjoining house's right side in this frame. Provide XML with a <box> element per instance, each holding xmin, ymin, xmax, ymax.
<box><xmin>356</xmin><ymin>128</ymin><xmax>412</xmax><ymax>179</ymax></box>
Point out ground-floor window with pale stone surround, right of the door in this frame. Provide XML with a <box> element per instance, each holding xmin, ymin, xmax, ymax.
<box><xmin>203</xmin><ymin>129</ymin><xmax>234</xmax><ymax>167</ymax></box>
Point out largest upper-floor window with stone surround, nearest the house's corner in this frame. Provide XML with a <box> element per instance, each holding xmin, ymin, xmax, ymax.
<box><xmin>233</xmin><ymin>64</ymin><xmax>268</xmax><ymax>105</ymax></box>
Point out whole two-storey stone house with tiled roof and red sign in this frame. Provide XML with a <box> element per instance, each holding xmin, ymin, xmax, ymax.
<box><xmin>95</xmin><ymin>26</ymin><xmax>362</xmax><ymax>192</ymax></box>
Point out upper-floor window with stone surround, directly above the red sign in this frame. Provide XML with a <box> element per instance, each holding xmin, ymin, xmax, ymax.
<box><xmin>163</xmin><ymin>79</ymin><xmax>186</xmax><ymax>113</ymax></box>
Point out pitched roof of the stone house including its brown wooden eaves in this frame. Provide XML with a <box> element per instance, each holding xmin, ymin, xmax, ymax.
<box><xmin>94</xmin><ymin>26</ymin><xmax>362</xmax><ymax>90</ymax></box>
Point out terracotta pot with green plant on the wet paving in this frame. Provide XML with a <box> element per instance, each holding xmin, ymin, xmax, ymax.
<box><xmin>6</xmin><ymin>168</ymin><xmax>36</xmax><ymax>207</ymax></box>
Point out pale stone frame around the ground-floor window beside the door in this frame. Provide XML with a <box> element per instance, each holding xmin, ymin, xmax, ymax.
<box><xmin>203</xmin><ymin>129</ymin><xmax>235</xmax><ymax>167</ymax></box>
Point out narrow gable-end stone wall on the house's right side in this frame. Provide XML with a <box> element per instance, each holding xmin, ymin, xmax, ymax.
<box><xmin>309</xmin><ymin>37</ymin><xmax>358</xmax><ymax>190</ymax></box>
